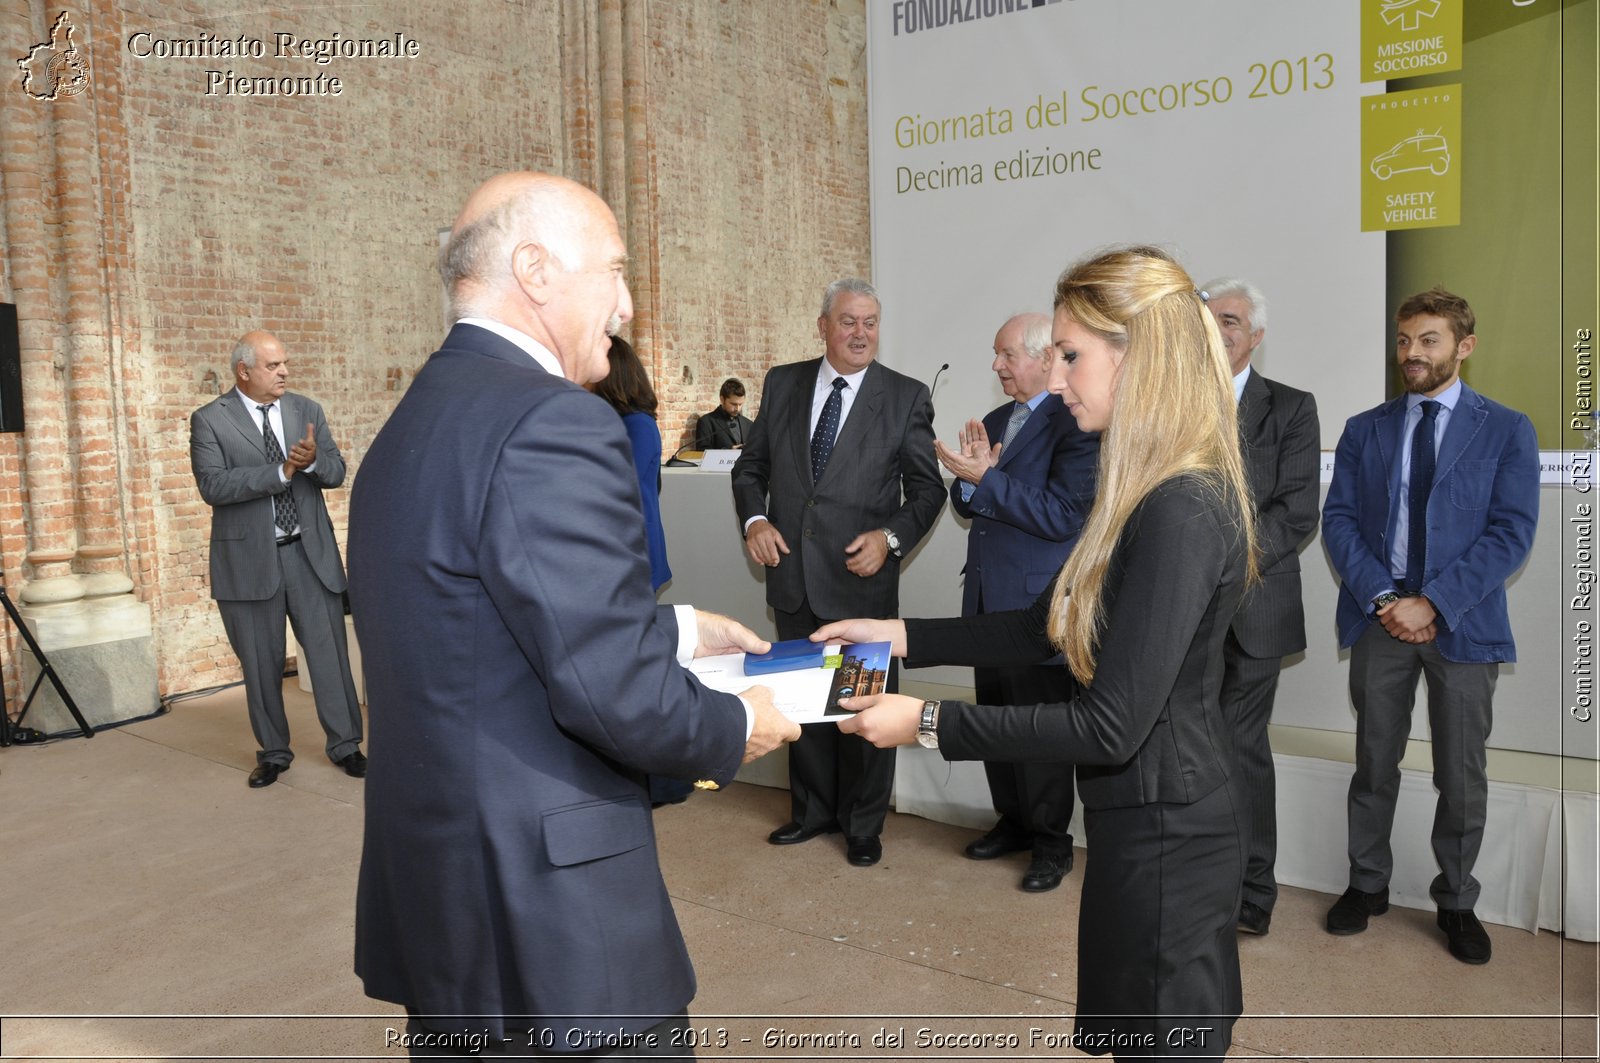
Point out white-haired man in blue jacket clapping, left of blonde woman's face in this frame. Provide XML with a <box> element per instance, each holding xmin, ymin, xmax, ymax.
<box><xmin>936</xmin><ymin>314</ymin><xmax>1099</xmax><ymax>893</ymax></box>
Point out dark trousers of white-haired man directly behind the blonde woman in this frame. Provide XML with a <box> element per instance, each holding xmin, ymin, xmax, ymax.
<box><xmin>1221</xmin><ymin>631</ymin><xmax>1283</xmax><ymax>911</ymax></box>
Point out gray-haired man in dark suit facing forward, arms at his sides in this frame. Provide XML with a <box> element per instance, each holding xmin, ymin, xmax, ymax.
<box><xmin>733</xmin><ymin>279</ymin><xmax>944</xmax><ymax>866</ymax></box>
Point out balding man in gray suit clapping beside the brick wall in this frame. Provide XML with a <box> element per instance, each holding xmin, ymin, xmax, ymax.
<box><xmin>189</xmin><ymin>331</ymin><xmax>366</xmax><ymax>788</ymax></box>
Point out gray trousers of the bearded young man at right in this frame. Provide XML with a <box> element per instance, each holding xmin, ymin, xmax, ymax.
<box><xmin>1349</xmin><ymin>623</ymin><xmax>1499</xmax><ymax>908</ymax></box>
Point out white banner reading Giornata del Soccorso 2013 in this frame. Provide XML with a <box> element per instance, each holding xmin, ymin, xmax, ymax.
<box><xmin>867</xmin><ymin>0</ymin><xmax>1382</xmax><ymax>438</ymax></box>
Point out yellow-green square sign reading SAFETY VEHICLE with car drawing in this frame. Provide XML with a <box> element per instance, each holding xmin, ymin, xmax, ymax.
<box><xmin>1362</xmin><ymin>85</ymin><xmax>1461</xmax><ymax>232</ymax></box>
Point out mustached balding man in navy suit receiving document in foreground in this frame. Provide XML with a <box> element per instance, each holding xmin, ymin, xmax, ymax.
<box><xmin>350</xmin><ymin>173</ymin><xmax>800</xmax><ymax>1057</ymax></box>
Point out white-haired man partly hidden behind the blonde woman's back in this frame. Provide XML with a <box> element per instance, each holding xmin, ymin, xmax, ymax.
<box><xmin>1203</xmin><ymin>277</ymin><xmax>1322</xmax><ymax>933</ymax></box>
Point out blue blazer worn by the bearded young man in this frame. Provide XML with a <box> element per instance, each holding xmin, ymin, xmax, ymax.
<box><xmin>1322</xmin><ymin>384</ymin><xmax>1539</xmax><ymax>663</ymax></box>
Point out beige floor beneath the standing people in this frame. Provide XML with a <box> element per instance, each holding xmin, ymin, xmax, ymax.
<box><xmin>0</xmin><ymin>684</ymin><xmax>1597</xmax><ymax>1060</ymax></box>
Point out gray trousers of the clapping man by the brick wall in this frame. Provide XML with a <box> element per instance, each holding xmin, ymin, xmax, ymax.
<box><xmin>216</xmin><ymin>543</ymin><xmax>362</xmax><ymax>765</ymax></box>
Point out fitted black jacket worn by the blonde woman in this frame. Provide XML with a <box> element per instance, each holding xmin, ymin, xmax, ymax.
<box><xmin>906</xmin><ymin>477</ymin><xmax>1245</xmax><ymax>810</ymax></box>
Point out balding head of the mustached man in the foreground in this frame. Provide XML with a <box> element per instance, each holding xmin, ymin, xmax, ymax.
<box><xmin>438</xmin><ymin>173</ymin><xmax>634</xmax><ymax>383</ymax></box>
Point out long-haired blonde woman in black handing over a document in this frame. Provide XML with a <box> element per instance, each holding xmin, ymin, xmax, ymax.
<box><xmin>813</xmin><ymin>247</ymin><xmax>1258</xmax><ymax>1058</ymax></box>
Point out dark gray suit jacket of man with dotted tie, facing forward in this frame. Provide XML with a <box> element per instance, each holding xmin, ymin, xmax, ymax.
<box><xmin>733</xmin><ymin>359</ymin><xmax>944</xmax><ymax>620</ymax></box>
